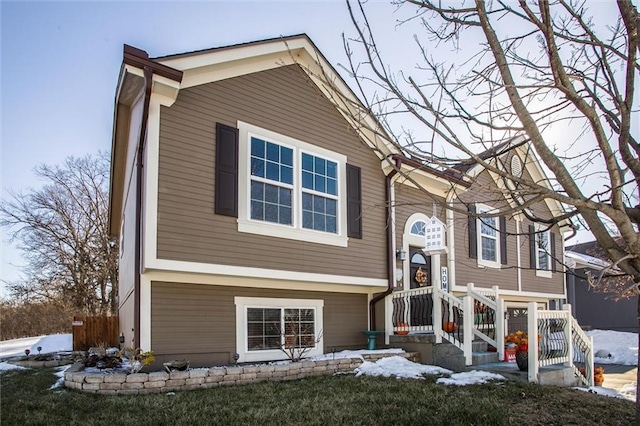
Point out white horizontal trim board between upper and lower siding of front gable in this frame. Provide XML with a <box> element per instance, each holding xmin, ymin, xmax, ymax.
<box><xmin>144</xmin><ymin>266</ymin><xmax>387</xmax><ymax>294</ymax></box>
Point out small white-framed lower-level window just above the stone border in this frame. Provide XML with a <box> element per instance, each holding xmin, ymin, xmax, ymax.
<box><xmin>235</xmin><ymin>297</ymin><xmax>324</xmax><ymax>362</ymax></box>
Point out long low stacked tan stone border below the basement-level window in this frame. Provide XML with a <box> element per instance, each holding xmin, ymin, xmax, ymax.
<box><xmin>64</xmin><ymin>352</ymin><xmax>419</xmax><ymax>395</ymax></box>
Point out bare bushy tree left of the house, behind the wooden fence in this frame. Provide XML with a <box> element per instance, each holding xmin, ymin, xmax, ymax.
<box><xmin>0</xmin><ymin>153</ymin><xmax>118</xmax><ymax>315</ymax></box>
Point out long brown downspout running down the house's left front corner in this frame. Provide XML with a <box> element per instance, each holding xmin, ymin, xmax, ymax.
<box><xmin>133</xmin><ymin>66</ymin><xmax>153</xmax><ymax>349</ymax></box>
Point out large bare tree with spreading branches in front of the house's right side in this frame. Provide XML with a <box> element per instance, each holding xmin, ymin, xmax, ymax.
<box><xmin>344</xmin><ymin>0</ymin><xmax>640</xmax><ymax>419</ymax></box>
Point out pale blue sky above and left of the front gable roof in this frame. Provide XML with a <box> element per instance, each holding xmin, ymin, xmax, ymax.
<box><xmin>0</xmin><ymin>0</ymin><xmax>615</xmax><ymax>294</ymax></box>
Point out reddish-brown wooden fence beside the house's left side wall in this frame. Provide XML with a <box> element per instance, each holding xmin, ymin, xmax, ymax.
<box><xmin>73</xmin><ymin>316</ymin><xmax>119</xmax><ymax>351</ymax></box>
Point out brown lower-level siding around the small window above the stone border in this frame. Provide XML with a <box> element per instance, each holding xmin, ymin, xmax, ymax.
<box><xmin>151</xmin><ymin>282</ymin><xmax>367</xmax><ymax>366</ymax></box>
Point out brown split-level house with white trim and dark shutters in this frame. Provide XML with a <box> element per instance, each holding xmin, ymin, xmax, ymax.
<box><xmin>110</xmin><ymin>35</ymin><xmax>580</xmax><ymax>372</ymax></box>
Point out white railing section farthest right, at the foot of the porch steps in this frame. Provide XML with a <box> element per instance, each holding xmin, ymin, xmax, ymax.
<box><xmin>528</xmin><ymin>302</ymin><xmax>594</xmax><ymax>386</ymax></box>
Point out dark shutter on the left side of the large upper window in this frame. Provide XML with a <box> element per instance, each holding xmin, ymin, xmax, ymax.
<box><xmin>215</xmin><ymin>123</ymin><xmax>238</xmax><ymax>217</ymax></box>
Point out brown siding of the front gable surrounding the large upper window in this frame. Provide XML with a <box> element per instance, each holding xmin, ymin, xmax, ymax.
<box><xmin>157</xmin><ymin>66</ymin><xmax>386</xmax><ymax>278</ymax></box>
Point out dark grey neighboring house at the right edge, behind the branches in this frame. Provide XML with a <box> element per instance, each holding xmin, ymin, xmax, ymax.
<box><xmin>565</xmin><ymin>241</ymin><xmax>638</xmax><ymax>333</ymax></box>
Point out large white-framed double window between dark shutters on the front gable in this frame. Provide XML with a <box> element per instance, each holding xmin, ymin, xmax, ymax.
<box><xmin>238</xmin><ymin>122</ymin><xmax>347</xmax><ymax>247</ymax></box>
